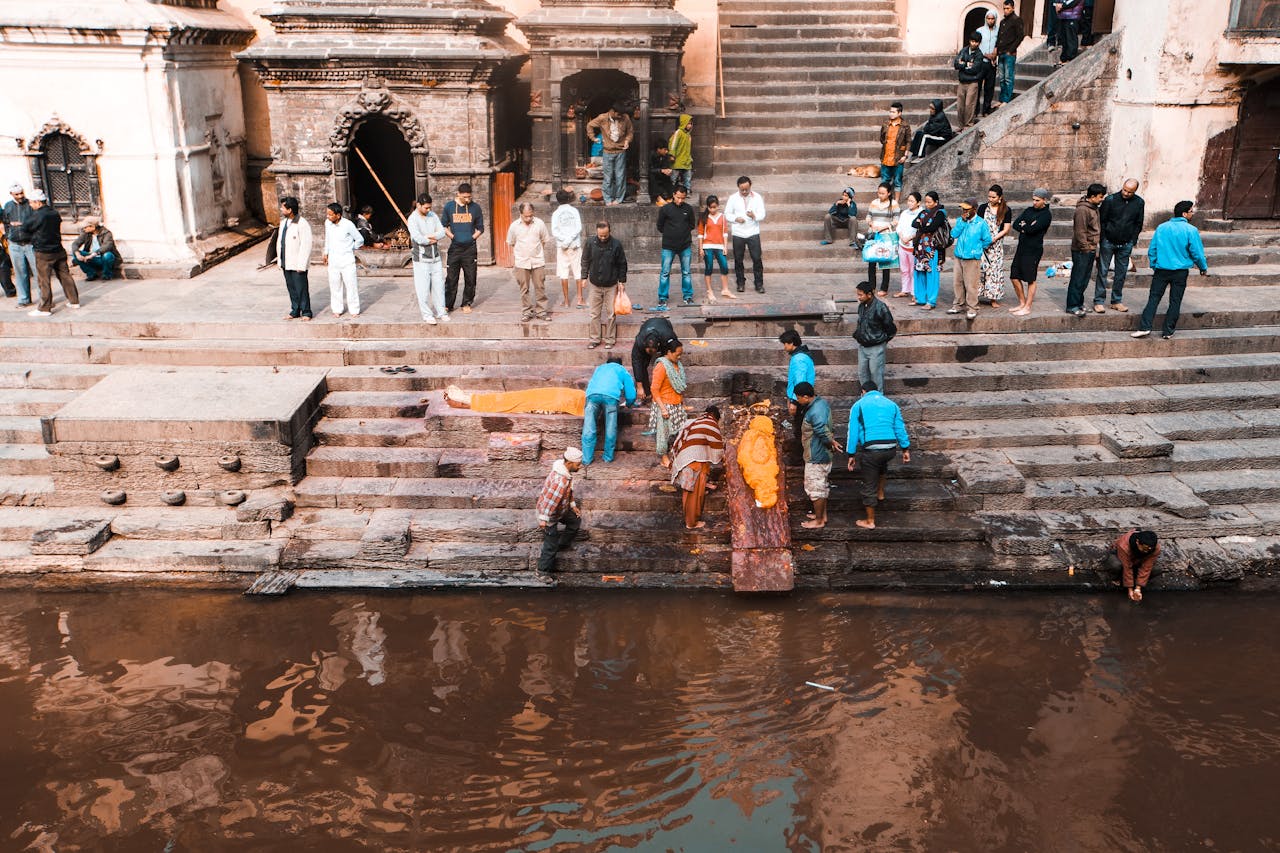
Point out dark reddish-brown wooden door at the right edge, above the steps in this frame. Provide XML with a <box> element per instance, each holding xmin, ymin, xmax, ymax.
<box><xmin>1225</xmin><ymin>79</ymin><xmax>1280</xmax><ymax>219</ymax></box>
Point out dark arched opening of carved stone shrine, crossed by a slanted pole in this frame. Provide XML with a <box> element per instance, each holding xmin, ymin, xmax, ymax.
<box><xmin>347</xmin><ymin>115</ymin><xmax>414</xmax><ymax>233</ymax></box>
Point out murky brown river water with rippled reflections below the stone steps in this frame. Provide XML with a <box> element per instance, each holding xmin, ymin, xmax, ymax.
<box><xmin>0</xmin><ymin>590</ymin><xmax>1280</xmax><ymax>853</ymax></box>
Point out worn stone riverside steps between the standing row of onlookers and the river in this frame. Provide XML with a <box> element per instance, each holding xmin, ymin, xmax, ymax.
<box><xmin>0</xmin><ymin>249</ymin><xmax>1280</xmax><ymax>592</ymax></box>
